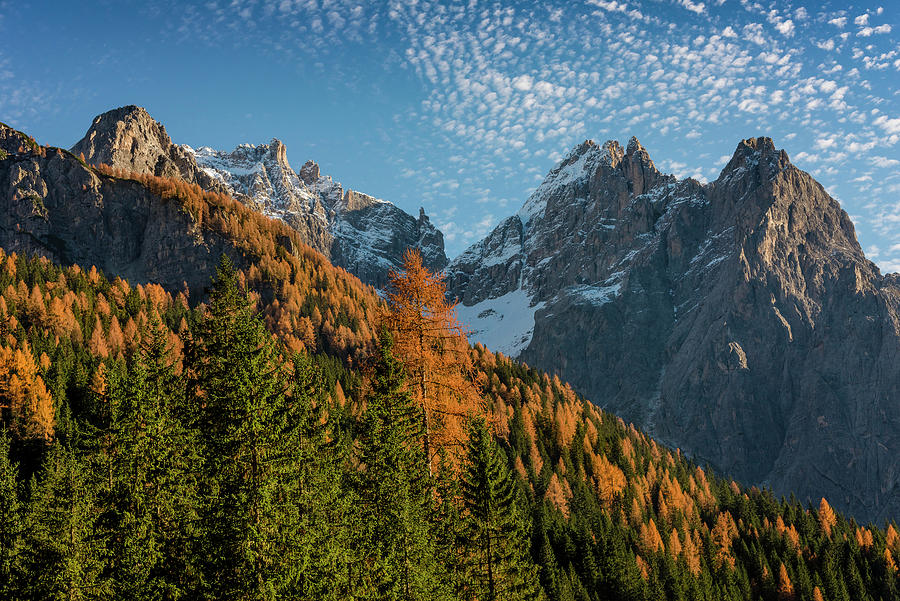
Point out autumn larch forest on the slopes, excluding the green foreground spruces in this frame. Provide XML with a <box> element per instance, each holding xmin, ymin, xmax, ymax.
<box><xmin>0</xmin><ymin>138</ymin><xmax>900</xmax><ymax>601</ymax></box>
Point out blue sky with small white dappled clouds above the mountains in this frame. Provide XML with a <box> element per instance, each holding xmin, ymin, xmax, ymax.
<box><xmin>0</xmin><ymin>0</ymin><xmax>900</xmax><ymax>271</ymax></box>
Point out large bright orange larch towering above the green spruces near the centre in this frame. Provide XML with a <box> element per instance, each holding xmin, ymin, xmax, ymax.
<box><xmin>382</xmin><ymin>249</ymin><xmax>483</xmax><ymax>470</ymax></box>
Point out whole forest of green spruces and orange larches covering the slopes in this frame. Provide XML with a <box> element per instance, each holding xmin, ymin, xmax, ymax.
<box><xmin>0</xmin><ymin>138</ymin><xmax>900</xmax><ymax>601</ymax></box>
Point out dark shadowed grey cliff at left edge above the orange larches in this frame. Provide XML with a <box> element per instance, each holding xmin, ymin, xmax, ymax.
<box><xmin>0</xmin><ymin>124</ymin><xmax>242</xmax><ymax>290</ymax></box>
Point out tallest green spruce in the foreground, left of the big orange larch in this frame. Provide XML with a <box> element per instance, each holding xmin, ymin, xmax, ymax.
<box><xmin>186</xmin><ymin>257</ymin><xmax>316</xmax><ymax>599</ymax></box>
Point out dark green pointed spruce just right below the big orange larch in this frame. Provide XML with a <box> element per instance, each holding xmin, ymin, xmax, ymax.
<box><xmin>462</xmin><ymin>417</ymin><xmax>543</xmax><ymax>601</ymax></box>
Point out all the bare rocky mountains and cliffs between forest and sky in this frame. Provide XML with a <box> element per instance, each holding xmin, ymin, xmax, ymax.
<box><xmin>0</xmin><ymin>106</ymin><xmax>900</xmax><ymax>520</ymax></box>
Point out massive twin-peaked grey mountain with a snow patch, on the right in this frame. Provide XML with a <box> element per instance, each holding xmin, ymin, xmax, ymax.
<box><xmin>447</xmin><ymin>138</ymin><xmax>900</xmax><ymax>519</ymax></box>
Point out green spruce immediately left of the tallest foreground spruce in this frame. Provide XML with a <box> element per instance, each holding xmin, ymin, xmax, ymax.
<box><xmin>97</xmin><ymin>315</ymin><xmax>198</xmax><ymax>600</ymax></box>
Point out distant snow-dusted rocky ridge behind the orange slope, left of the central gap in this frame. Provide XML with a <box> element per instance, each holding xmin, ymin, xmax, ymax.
<box><xmin>72</xmin><ymin>106</ymin><xmax>447</xmax><ymax>287</ymax></box>
